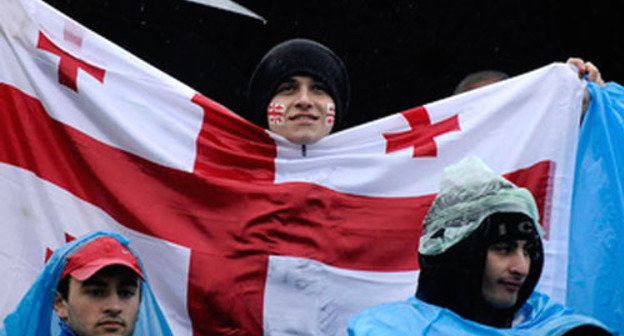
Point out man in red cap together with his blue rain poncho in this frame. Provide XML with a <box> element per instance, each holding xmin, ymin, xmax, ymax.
<box><xmin>0</xmin><ymin>232</ymin><xmax>172</xmax><ymax>336</ymax></box>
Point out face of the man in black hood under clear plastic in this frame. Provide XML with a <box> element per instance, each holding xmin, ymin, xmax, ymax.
<box><xmin>481</xmin><ymin>240</ymin><xmax>531</xmax><ymax>309</ymax></box>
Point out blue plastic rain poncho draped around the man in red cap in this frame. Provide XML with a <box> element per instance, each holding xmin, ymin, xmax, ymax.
<box><xmin>0</xmin><ymin>232</ymin><xmax>173</xmax><ymax>336</ymax></box>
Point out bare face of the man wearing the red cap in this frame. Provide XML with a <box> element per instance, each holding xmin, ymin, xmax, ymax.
<box><xmin>54</xmin><ymin>266</ymin><xmax>141</xmax><ymax>336</ymax></box>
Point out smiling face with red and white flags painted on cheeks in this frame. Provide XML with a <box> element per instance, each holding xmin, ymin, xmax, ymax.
<box><xmin>267</xmin><ymin>76</ymin><xmax>336</xmax><ymax>144</ymax></box>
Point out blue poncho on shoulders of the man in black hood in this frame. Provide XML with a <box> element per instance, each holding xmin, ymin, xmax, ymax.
<box><xmin>348</xmin><ymin>292</ymin><xmax>606</xmax><ymax>336</ymax></box>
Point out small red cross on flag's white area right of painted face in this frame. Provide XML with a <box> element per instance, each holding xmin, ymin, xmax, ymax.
<box><xmin>383</xmin><ymin>106</ymin><xmax>460</xmax><ymax>157</ymax></box>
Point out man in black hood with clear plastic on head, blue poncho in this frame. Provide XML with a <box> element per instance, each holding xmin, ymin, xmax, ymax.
<box><xmin>349</xmin><ymin>158</ymin><xmax>610</xmax><ymax>336</ymax></box>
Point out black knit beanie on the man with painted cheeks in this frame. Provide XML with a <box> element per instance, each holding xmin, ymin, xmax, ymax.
<box><xmin>247</xmin><ymin>39</ymin><xmax>351</xmax><ymax>128</ymax></box>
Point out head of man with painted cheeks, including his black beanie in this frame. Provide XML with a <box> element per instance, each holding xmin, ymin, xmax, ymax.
<box><xmin>248</xmin><ymin>39</ymin><xmax>351</xmax><ymax>154</ymax></box>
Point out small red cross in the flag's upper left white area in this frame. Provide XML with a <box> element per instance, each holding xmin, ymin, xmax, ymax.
<box><xmin>37</xmin><ymin>32</ymin><xmax>106</xmax><ymax>92</ymax></box>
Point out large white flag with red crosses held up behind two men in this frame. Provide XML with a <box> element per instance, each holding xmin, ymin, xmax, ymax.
<box><xmin>0</xmin><ymin>0</ymin><xmax>583</xmax><ymax>336</ymax></box>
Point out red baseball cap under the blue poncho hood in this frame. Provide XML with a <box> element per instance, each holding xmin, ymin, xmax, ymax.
<box><xmin>61</xmin><ymin>236</ymin><xmax>145</xmax><ymax>281</ymax></box>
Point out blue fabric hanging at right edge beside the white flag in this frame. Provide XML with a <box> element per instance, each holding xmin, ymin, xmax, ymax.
<box><xmin>567</xmin><ymin>83</ymin><xmax>624</xmax><ymax>334</ymax></box>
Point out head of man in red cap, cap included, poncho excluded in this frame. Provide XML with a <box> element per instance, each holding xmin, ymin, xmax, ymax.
<box><xmin>54</xmin><ymin>236</ymin><xmax>145</xmax><ymax>336</ymax></box>
